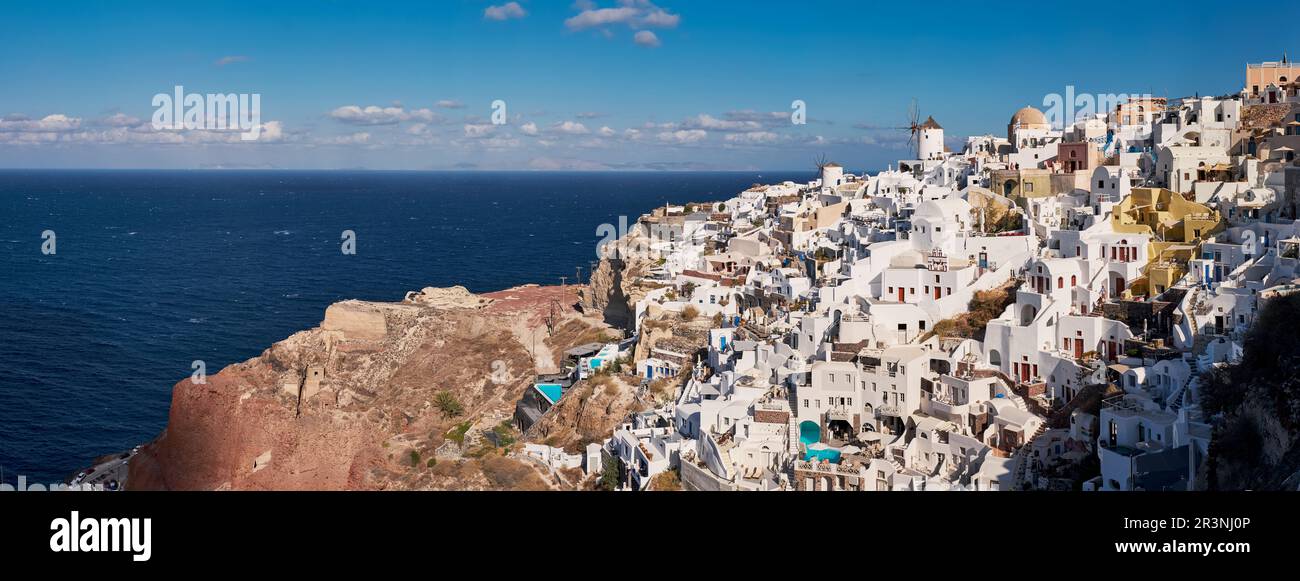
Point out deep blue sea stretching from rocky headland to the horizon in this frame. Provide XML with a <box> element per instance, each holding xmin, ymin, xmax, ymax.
<box><xmin>0</xmin><ymin>170</ymin><xmax>813</xmax><ymax>482</ymax></box>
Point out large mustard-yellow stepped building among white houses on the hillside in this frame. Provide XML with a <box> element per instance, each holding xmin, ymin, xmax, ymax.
<box><xmin>1110</xmin><ymin>187</ymin><xmax>1227</xmax><ymax>295</ymax></box>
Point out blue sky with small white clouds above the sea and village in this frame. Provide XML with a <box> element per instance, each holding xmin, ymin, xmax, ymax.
<box><xmin>0</xmin><ymin>0</ymin><xmax>1300</xmax><ymax>169</ymax></box>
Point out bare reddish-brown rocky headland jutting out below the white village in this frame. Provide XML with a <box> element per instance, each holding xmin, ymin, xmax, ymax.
<box><xmin>127</xmin><ymin>286</ymin><xmax>603</xmax><ymax>490</ymax></box>
